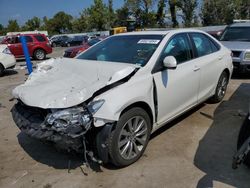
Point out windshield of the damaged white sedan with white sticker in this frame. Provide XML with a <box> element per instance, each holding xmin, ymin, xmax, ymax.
<box><xmin>77</xmin><ymin>35</ymin><xmax>164</xmax><ymax>66</ymax></box>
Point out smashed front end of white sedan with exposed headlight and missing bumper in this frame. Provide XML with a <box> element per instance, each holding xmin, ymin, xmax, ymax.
<box><xmin>11</xmin><ymin>101</ymin><xmax>112</xmax><ymax>163</ymax></box>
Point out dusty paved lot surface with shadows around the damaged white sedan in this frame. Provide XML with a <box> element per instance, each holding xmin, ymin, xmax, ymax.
<box><xmin>0</xmin><ymin>48</ymin><xmax>250</xmax><ymax>188</ymax></box>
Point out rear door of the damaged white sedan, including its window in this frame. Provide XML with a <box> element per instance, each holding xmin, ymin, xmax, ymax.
<box><xmin>189</xmin><ymin>33</ymin><xmax>224</xmax><ymax>102</ymax></box>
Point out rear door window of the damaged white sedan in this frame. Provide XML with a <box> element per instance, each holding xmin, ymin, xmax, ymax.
<box><xmin>190</xmin><ymin>33</ymin><xmax>218</xmax><ymax>57</ymax></box>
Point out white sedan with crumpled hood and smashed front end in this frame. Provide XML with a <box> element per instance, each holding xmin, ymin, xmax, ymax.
<box><xmin>12</xmin><ymin>30</ymin><xmax>233</xmax><ymax>166</ymax></box>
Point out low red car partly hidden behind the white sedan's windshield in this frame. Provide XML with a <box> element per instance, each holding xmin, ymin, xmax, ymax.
<box><xmin>63</xmin><ymin>38</ymin><xmax>101</xmax><ymax>58</ymax></box>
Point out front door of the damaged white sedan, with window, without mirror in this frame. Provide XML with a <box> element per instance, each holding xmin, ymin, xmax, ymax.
<box><xmin>153</xmin><ymin>33</ymin><xmax>200</xmax><ymax>125</ymax></box>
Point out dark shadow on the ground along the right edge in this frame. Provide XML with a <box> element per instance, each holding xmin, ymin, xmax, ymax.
<box><xmin>194</xmin><ymin>84</ymin><xmax>250</xmax><ymax>188</ymax></box>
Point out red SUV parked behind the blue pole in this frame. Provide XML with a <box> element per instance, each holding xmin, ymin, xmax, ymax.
<box><xmin>2</xmin><ymin>34</ymin><xmax>52</xmax><ymax>60</ymax></box>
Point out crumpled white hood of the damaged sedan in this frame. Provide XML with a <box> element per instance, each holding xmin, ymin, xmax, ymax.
<box><xmin>12</xmin><ymin>58</ymin><xmax>137</xmax><ymax>109</ymax></box>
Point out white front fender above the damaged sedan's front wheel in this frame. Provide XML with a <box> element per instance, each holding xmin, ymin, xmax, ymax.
<box><xmin>93</xmin><ymin>70</ymin><xmax>155</xmax><ymax>127</ymax></box>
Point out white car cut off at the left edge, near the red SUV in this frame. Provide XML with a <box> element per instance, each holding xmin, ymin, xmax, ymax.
<box><xmin>0</xmin><ymin>44</ymin><xmax>16</xmax><ymax>76</ymax></box>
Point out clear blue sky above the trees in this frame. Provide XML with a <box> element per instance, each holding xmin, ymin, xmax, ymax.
<box><xmin>0</xmin><ymin>0</ymin><xmax>124</xmax><ymax>26</ymax></box>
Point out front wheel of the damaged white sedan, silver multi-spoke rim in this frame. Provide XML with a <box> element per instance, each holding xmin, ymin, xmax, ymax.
<box><xmin>108</xmin><ymin>107</ymin><xmax>151</xmax><ymax>167</ymax></box>
